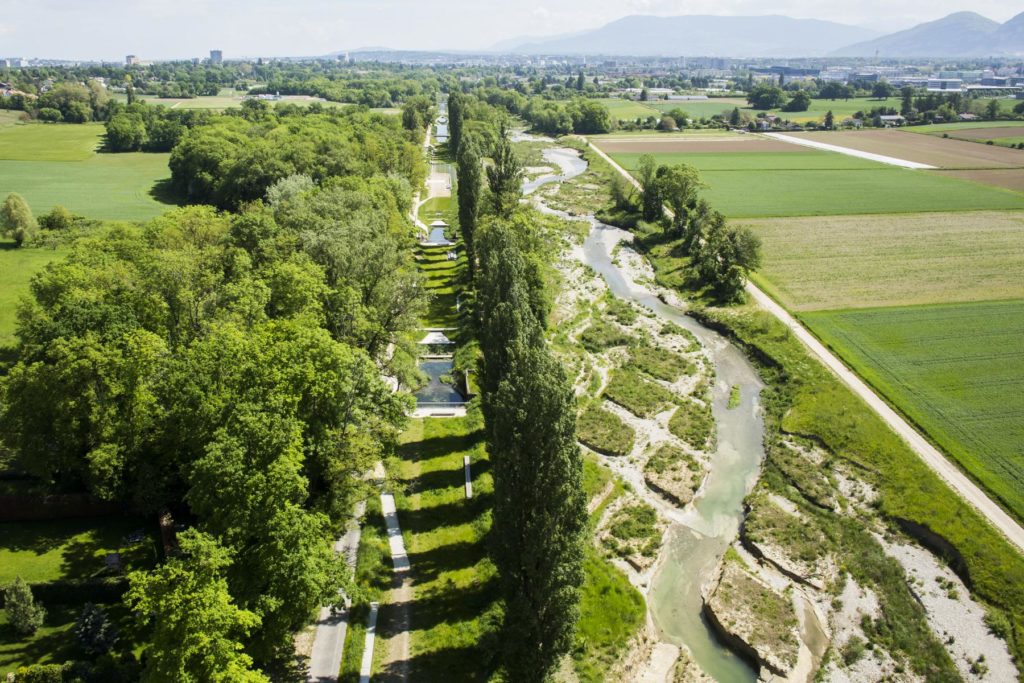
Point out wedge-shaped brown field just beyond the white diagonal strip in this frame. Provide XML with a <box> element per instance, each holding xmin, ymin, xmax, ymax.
<box><xmin>774</xmin><ymin>128</ymin><xmax>1024</xmax><ymax>168</ymax></box>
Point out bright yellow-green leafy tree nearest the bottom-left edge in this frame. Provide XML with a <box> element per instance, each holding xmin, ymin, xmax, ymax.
<box><xmin>125</xmin><ymin>529</ymin><xmax>269</xmax><ymax>683</ymax></box>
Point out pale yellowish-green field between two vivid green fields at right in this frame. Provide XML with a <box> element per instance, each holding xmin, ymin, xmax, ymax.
<box><xmin>741</xmin><ymin>211</ymin><xmax>1024</xmax><ymax>311</ymax></box>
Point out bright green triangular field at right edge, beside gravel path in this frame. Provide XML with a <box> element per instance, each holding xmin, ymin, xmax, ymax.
<box><xmin>803</xmin><ymin>300</ymin><xmax>1024</xmax><ymax>519</ymax></box>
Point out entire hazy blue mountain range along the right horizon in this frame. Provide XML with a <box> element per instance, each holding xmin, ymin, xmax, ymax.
<box><xmin>494</xmin><ymin>12</ymin><xmax>1024</xmax><ymax>57</ymax></box>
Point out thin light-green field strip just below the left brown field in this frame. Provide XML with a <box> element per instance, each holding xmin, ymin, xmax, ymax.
<box><xmin>610</xmin><ymin>150</ymin><xmax>886</xmax><ymax>171</ymax></box>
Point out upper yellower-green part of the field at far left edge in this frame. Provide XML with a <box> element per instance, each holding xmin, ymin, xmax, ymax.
<box><xmin>0</xmin><ymin>123</ymin><xmax>104</xmax><ymax>161</ymax></box>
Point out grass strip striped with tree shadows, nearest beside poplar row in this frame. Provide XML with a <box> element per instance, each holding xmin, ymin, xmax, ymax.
<box><xmin>395</xmin><ymin>414</ymin><xmax>498</xmax><ymax>681</ymax></box>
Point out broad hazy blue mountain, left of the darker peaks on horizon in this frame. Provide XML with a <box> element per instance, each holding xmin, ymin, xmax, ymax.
<box><xmin>509</xmin><ymin>15</ymin><xmax>878</xmax><ymax>57</ymax></box>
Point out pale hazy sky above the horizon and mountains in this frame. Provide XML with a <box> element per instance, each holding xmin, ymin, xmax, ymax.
<box><xmin>0</xmin><ymin>0</ymin><xmax>1021</xmax><ymax>59</ymax></box>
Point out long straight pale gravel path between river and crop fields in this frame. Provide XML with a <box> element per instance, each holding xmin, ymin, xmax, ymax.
<box><xmin>587</xmin><ymin>138</ymin><xmax>1024</xmax><ymax>551</ymax></box>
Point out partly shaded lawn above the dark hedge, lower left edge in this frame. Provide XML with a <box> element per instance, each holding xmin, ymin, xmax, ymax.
<box><xmin>0</xmin><ymin>517</ymin><xmax>157</xmax><ymax>586</ymax></box>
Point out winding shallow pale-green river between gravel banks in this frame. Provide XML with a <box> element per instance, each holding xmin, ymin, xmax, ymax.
<box><xmin>541</xmin><ymin>150</ymin><xmax>764</xmax><ymax>683</ymax></box>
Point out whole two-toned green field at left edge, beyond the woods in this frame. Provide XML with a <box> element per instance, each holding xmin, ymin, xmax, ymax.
<box><xmin>0</xmin><ymin>124</ymin><xmax>170</xmax><ymax>220</ymax></box>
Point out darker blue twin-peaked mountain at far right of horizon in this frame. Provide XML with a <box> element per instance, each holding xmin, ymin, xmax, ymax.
<box><xmin>833</xmin><ymin>12</ymin><xmax>1024</xmax><ymax>57</ymax></box>
